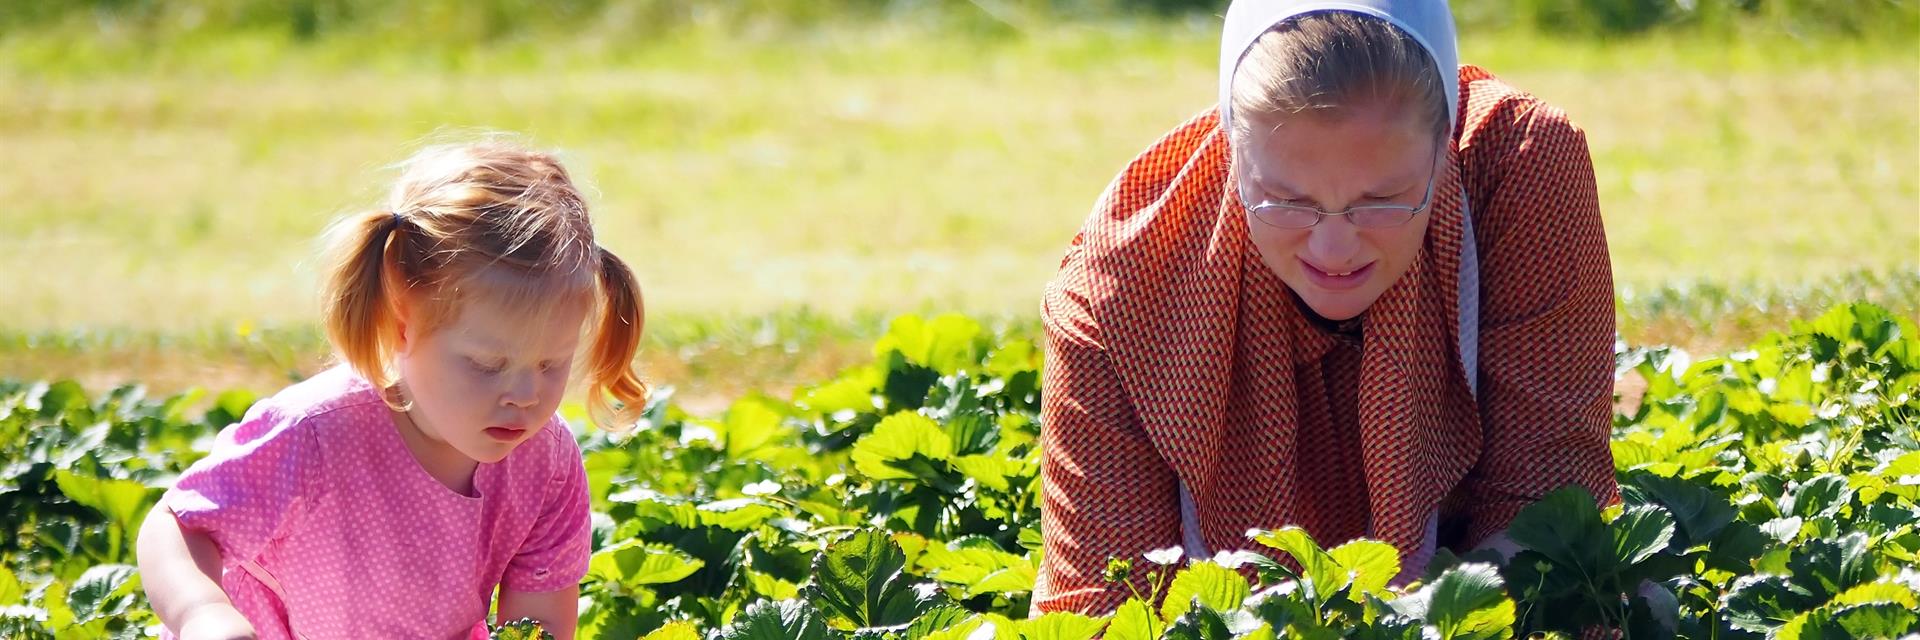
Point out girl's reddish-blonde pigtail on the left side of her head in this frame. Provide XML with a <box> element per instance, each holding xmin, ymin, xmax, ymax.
<box><xmin>323</xmin><ymin>211</ymin><xmax>405</xmax><ymax>395</ymax></box>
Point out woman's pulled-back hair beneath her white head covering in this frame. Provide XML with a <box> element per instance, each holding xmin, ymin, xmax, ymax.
<box><xmin>1231</xmin><ymin>12</ymin><xmax>1453</xmax><ymax>138</ymax></box>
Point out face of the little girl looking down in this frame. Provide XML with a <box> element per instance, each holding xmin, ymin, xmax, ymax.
<box><xmin>399</xmin><ymin>292</ymin><xmax>589</xmax><ymax>463</ymax></box>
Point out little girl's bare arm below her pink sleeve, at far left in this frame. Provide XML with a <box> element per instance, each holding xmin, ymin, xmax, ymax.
<box><xmin>136</xmin><ymin>505</ymin><xmax>253</xmax><ymax>640</ymax></box>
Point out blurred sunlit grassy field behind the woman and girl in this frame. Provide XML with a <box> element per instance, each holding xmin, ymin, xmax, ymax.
<box><xmin>0</xmin><ymin>0</ymin><xmax>1920</xmax><ymax>405</ymax></box>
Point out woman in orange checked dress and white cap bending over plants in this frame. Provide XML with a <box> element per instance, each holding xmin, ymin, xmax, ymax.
<box><xmin>1035</xmin><ymin>0</ymin><xmax>1619</xmax><ymax>613</ymax></box>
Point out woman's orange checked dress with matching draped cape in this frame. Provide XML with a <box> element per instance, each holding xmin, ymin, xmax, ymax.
<box><xmin>1033</xmin><ymin>65</ymin><xmax>1619</xmax><ymax>613</ymax></box>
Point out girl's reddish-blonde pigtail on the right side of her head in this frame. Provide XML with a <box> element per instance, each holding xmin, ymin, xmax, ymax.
<box><xmin>586</xmin><ymin>250</ymin><xmax>649</xmax><ymax>429</ymax></box>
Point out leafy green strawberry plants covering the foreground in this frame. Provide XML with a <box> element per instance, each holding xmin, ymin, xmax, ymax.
<box><xmin>0</xmin><ymin>304</ymin><xmax>1920</xmax><ymax>640</ymax></box>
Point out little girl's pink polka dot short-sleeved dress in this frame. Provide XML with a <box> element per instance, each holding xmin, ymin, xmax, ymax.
<box><xmin>161</xmin><ymin>367</ymin><xmax>591</xmax><ymax>640</ymax></box>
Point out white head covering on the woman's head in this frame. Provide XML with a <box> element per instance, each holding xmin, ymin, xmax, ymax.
<box><xmin>1219</xmin><ymin>0</ymin><xmax>1459</xmax><ymax>131</ymax></box>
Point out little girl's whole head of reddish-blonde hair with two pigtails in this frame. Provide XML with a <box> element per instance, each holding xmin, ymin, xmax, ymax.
<box><xmin>324</xmin><ymin>140</ymin><xmax>647</xmax><ymax>429</ymax></box>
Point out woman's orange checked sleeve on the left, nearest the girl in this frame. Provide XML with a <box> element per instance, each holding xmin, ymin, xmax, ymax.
<box><xmin>1033</xmin><ymin>248</ymin><xmax>1179</xmax><ymax>615</ymax></box>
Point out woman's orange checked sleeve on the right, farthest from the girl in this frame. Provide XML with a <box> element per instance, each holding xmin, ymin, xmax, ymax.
<box><xmin>1465</xmin><ymin>96</ymin><xmax>1619</xmax><ymax>548</ymax></box>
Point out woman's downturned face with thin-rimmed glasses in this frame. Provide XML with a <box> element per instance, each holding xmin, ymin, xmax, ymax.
<box><xmin>1236</xmin><ymin>108</ymin><xmax>1438</xmax><ymax>321</ymax></box>
